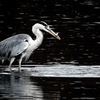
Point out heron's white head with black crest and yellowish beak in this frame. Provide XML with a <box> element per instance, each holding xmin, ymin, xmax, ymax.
<box><xmin>35</xmin><ymin>21</ymin><xmax>61</xmax><ymax>40</ymax></box>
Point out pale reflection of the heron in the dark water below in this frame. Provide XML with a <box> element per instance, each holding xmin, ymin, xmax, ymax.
<box><xmin>0</xmin><ymin>75</ymin><xmax>43</xmax><ymax>100</ymax></box>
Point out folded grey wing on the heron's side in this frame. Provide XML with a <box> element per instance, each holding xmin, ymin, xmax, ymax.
<box><xmin>0</xmin><ymin>38</ymin><xmax>29</xmax><ymax>59</ymax></box>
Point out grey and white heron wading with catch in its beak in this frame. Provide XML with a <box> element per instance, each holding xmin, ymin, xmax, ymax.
<box><xmin>0</xmin><ymin>21</ymin><xmax>61</xmax><ymax>72</ymax></box>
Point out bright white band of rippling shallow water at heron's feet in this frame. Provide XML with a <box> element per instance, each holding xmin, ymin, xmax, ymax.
<box><xmin>0</xmin><ymin>64</ymin><xmax>100</xmax><ymax>78</ymax></box>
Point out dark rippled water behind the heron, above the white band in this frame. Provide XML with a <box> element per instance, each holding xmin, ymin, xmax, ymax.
<box><xmin>0</xmin><ymin>0</ymin><xmax>100</xmax><ymax>65</ymax></box>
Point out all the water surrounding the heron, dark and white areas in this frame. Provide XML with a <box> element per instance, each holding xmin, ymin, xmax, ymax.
<box><xmin>0</xmin><ymin>0</ymin><xmax>100</xmax><ymax>100</ymax></box>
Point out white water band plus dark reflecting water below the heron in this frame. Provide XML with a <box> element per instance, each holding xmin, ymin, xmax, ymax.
<box><xmin>0</xmin><ymin>64</ymin><xmax>100</xmax><ymax>100</ymax></box>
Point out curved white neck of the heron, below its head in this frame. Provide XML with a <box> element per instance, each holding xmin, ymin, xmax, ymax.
<box><xmin>32</xmin><ymin>28</ymin><xmax>43</xmax><ymax>47</ymax></box>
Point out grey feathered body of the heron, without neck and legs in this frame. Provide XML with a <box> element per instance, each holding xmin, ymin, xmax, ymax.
<box><xmin>0</xmin><ymin>34</ymin><xmax>36</xmax><ymax>60</ymax></box>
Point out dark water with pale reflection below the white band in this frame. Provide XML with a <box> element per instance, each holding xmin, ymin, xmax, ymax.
<box><xmin>0</xmin><ymin>68</ymin><xmax>100</xmax><ymax>100</ymax></box>
